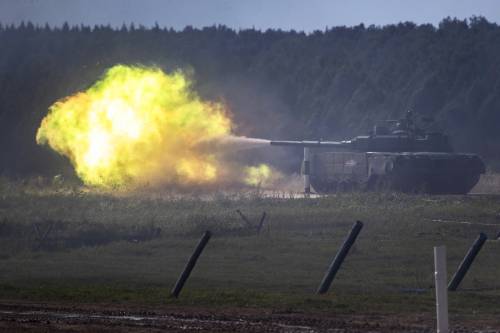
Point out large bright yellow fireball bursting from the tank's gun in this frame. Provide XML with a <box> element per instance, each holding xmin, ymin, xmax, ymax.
<box><xmin>36</xmin><ymin>65</ymin><xmax>231</xmax><ymax>187</ymax></box>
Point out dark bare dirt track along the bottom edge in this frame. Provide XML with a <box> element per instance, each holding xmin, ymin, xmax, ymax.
<box><xmin>0</xmin><ymin>302</ymin><xmax>500</xmax><ymax>333</ymax></box>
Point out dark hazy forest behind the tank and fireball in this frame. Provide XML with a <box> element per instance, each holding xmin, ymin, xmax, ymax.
<box><xmin>0</xmin><ymin>17</ymin><xmax>500</xmax><ymax>177</ymax></box>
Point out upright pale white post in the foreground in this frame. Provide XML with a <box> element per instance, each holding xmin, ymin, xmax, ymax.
<box><xmin>434</xmin><ymin>246</ymin><xmax>448</xmax><ymax>333</ymax></box>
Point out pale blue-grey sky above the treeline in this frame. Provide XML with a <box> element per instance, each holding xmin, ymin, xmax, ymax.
<box><xmin>0</xmin><ymin>0</ymin><xmax>500</xmax><ymax>32</ymax></box>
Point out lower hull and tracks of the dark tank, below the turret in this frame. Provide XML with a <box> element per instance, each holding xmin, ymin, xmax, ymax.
<box><xmin>310</xmin><ymin>152</ymin><xmax>485</xmax><ymax>194</ymax></box>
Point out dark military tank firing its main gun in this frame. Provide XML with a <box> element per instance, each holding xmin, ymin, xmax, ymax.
<box><xmin>271</xmin><ymin>112</ymin><xmax>485</xmax><ymax>194</ymax></box>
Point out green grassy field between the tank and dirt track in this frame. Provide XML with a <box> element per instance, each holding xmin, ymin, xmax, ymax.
<box><xmin>0</xmin><ymin>180</ymin><xmax>500</xmax><ymax>316</ymax></box>
